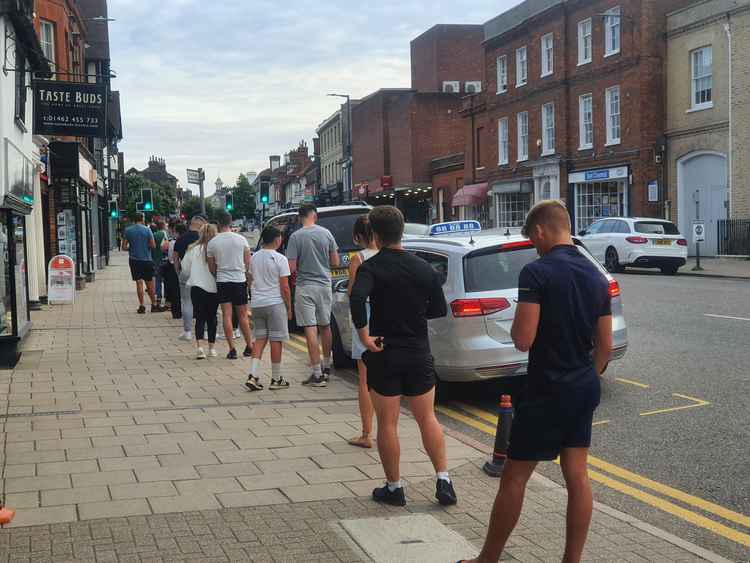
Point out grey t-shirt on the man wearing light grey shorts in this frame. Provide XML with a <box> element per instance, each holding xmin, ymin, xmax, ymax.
<box><xmin>286</xmin><ymin>225</ymin><xmax>339</xmax><ymax>287</ymax></box>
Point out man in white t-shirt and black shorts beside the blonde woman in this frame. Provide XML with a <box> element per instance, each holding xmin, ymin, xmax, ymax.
<box><xmin>206</xmin><ymin>211</ymin><xmax>253</xmax><ymax>360</ymax></box>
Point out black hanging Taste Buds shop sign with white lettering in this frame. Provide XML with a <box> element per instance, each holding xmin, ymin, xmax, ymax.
<box><xmin>34</xmin><ymin>80</ymin><xmax>106</xmax><ymax>138</ymax></box>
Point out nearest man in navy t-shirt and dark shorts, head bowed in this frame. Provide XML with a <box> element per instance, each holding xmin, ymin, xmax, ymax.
<box><xmin>464</xmin><ymin>201</ymin><xmax>612</xmax><ymax>562</ymax></box>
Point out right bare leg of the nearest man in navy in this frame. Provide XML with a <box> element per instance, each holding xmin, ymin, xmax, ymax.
<box><xmin>560</xmin><ymin>448</ymin><xmax>594</xmax><ymax>563</ymax></box>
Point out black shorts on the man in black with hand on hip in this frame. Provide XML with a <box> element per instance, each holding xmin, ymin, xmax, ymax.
<box><xmin>362</xmin><ymin>344</ymin><xmax>437</xmax><ymax>397</ymax></box>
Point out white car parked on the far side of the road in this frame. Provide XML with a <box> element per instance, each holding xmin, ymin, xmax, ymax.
<box><xmin>579</xmin><ymin>217</ymin><xmax>688</xmax><ymax>275</ymax></box>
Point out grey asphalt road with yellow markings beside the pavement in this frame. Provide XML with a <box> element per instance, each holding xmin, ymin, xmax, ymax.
<box><xmin>428</xmin><ymin>274</ymin><xmax>750</xmax><ymax>561</ymax></box>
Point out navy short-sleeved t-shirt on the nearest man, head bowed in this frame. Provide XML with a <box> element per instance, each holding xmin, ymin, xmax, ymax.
<box><xmin>518</xmin><ymin>245</ymin><xmax>612</xmax><ymax>394</ymax></box>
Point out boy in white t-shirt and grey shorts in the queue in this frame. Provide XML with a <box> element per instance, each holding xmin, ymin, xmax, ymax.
<box><xmin>245</xmin><ymin>226</ymin><xmax>292</xmax><ymax>391</ymax></box>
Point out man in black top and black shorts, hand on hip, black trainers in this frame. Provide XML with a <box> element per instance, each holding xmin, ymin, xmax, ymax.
<box><xmin>350</xmin><ymin>205</ymin><xmax>456</xmax><ymax>506</ymax></box>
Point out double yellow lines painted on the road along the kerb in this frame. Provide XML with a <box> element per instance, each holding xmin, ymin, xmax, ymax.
<box><xmin>435</xmin><ymin>403</ymin><xmax>750</xmax><ymax>547</ymax></box>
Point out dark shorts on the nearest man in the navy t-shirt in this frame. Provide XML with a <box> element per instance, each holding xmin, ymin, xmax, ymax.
<box><xmin>508</xmin><ymin>376</ymin><xmax>601</xmax><ymax>461</ymax></box>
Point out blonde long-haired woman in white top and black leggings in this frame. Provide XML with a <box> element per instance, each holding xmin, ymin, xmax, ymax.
<box><xmin>181</xmin><ymin>224</ymin><xmax>219</xmax><ymax>360</ymax></box>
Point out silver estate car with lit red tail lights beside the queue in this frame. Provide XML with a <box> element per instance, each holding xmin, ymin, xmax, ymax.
<box><xmin>331</xmin><ymin>229</ymin><xmax>628</xmax><ymax>382</ymax></box>
